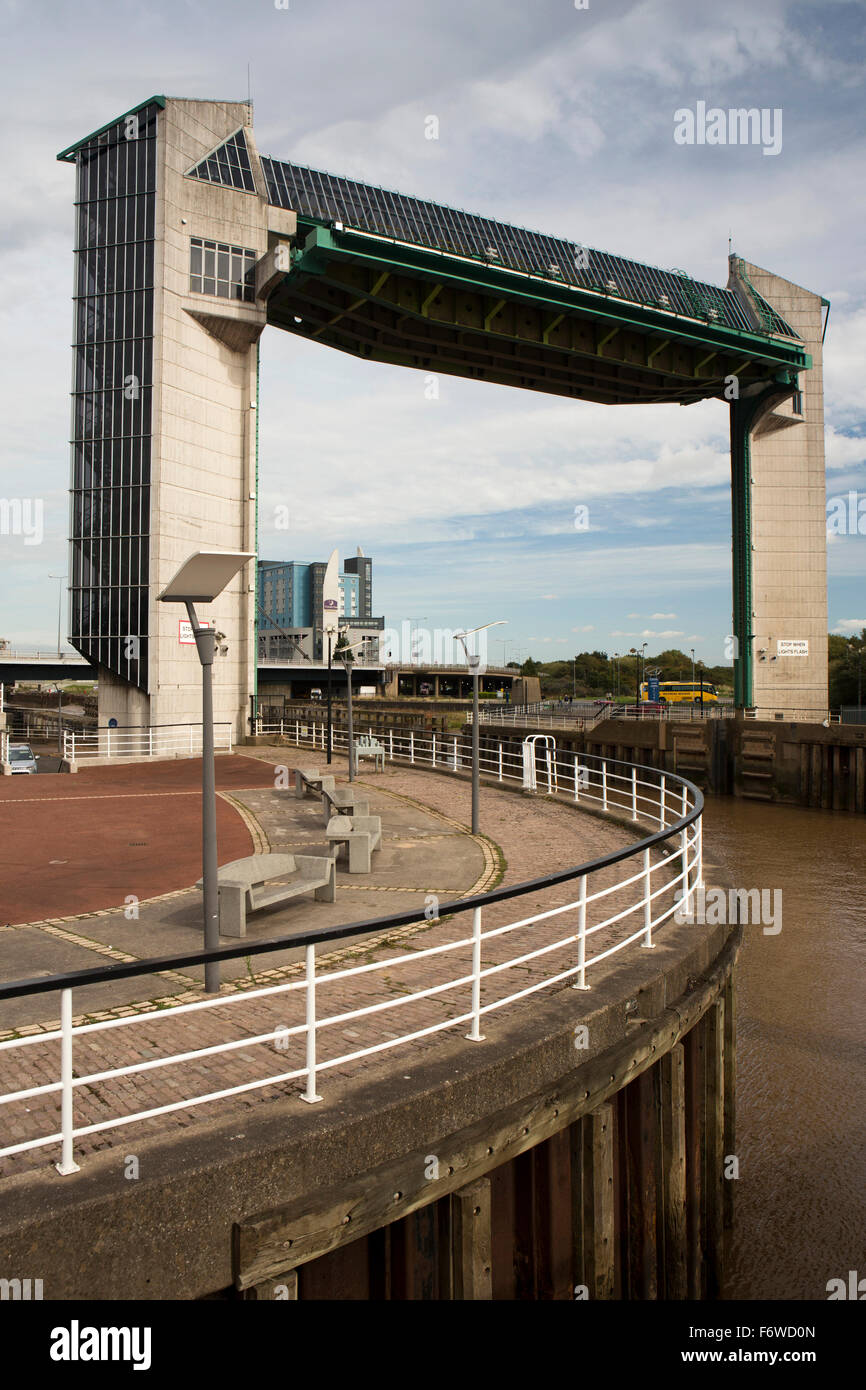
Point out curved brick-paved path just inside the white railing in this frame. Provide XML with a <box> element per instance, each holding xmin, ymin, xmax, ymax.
<box><xmin>0</xmin><ymin>749</ymin><xmax>683</xmax><ymax>1182</ymax></box>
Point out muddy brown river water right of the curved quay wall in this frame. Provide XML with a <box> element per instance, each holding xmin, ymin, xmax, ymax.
<box><xmin>705</xmin><ymin>798</ymin><xmax>866</xmax><ymax>1298</ymax></box>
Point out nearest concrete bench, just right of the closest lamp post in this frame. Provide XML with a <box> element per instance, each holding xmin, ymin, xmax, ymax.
<box><xmin>197</xmin><ymin>855</ymin><xmax>336</xmax><ymax>937</ymax></box>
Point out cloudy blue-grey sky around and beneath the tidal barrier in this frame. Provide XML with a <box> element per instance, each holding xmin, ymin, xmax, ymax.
<box><xmin>0</xmin><ymin>0</ymin><xmax>866</xmax><ymax>664</ymax></box>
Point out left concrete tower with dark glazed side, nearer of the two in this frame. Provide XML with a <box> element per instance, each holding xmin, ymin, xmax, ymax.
<box><xmin>58</xmin><ymin>97</ymin><xmax>296</xmax><ymax>737</ymax></box>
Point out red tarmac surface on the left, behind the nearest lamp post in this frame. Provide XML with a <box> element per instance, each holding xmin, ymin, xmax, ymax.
<box><xmin>0</xmin><ymin>755</ymin><xmax>274</xmax><ymax>924</ymax></box>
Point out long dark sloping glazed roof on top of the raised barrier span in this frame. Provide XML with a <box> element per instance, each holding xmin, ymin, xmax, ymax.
<box><xmin>261</xmin><ymin>157</ymin><xmax>796</xmax><ymax>338</ymax></box>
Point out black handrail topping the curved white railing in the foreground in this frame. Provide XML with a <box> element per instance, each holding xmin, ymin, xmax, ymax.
<box><xmin>0</xmin><ymin>753</ymin><xmax>703</xmax><ymax>1001</ymax></box>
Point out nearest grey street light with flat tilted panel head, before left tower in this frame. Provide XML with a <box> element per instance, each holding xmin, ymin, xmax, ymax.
<box><xmin>157</xmin><ymin>550</ymin><xmax>256</xmax><ymax>994</ymax></box>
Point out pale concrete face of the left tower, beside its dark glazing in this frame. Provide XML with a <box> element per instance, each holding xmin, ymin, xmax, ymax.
<box><xmin>100</xmin><ymin>99</ymin><xmax>295</xmax><ymax>737</ymax></box>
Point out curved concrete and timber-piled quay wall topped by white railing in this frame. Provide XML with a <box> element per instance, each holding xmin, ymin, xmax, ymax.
<box><xmin>0</xmin><ymin>727</ymin><xmax>740</xmax><ymax>1300</ymax></box>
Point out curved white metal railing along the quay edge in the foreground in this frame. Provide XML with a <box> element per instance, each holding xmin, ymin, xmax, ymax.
<box><xmin>0</xmin><ymin>721</ymin><xmax>703</xmax><ymax>1175</ymax></box>
